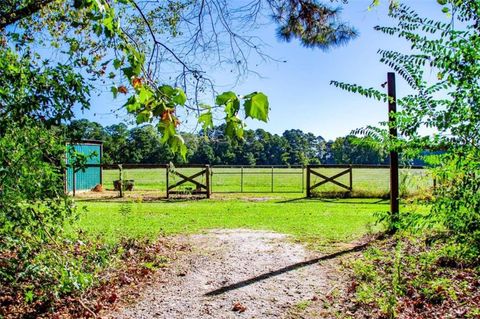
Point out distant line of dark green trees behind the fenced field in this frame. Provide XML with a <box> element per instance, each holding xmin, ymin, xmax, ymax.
<box><xmin>67</xmin><ymin>119</ymin><xmax>388</xmax><ymax>165</ymax></box>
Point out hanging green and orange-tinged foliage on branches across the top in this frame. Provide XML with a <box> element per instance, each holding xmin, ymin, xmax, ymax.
<box><xmin>0</xmin><ymin>0</ymin><xmax>356</xmax><ymax>156</ymax></box>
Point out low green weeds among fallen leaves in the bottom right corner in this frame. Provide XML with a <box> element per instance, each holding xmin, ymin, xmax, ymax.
<box><xmin>334</xmin><ymin>236</ymin><xmax>479</xmax><ymax>318</ymax></box>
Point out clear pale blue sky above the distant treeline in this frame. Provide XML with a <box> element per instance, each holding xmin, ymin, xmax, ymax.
<box><xmin>77</xmin><ymin>0</ymin><xmax>447</xmax><ymax>139</ymax></box>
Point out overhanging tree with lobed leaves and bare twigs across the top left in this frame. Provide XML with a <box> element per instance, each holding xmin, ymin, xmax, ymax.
<box><xmin>0</xmin><ymin>0</ymin><xmax>356</xmax><ymax>155</ymax></box>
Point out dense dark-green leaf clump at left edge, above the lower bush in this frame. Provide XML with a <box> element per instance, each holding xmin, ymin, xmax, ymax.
<box><xmin>0</xmin><ymin>47</ymin><xmax>90</xmax><ymax>132</ymax></box>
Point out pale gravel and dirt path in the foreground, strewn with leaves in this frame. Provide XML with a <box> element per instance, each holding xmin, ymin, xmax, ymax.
<box><xmin>111</xmin><ymin>229</ymin><xmax>340</xmax><ymax>319</ymax></box>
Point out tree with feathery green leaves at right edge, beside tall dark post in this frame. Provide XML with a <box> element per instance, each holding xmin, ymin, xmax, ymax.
<box><xmin>333</xmin><ymin>0</ymin><xmax>480</xmax><ymax>261</ymax></box>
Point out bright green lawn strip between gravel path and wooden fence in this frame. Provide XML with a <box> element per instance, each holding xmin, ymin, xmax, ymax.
<box><xmin>74</xmin><ymin>196</ymin><xmax>396</xmax><ymax>249</ymax></box>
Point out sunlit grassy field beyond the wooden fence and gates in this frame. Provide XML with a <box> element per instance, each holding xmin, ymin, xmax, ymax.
<box><xmin>104</xmin><ymin>167</ymin><xmax>433</xmax><ymax>197</ymax></box>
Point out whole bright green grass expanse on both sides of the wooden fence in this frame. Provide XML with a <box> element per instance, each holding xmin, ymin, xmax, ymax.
<box><xmin>79</xmin><ymin>168</ymin><xmax>431</xmax><ymax>250</ymax></box>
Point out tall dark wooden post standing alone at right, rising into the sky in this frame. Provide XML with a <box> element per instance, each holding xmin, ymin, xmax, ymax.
<box><xmin>387</xmin><ymin>72</ymin><xmax>400</xmax><ymax>230</ymax></box>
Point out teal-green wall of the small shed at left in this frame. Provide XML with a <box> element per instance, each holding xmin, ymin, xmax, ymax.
<box><xmin>66</xmin><ymin>143</ymin><xmax>102</xmax><ymax>192</ymax></box>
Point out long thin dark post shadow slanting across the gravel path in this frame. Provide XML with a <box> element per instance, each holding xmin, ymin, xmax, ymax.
<box><xmin>205</xmin><ymin>241</ymin><xmax>372</xmax><ymax>296</ymax></box>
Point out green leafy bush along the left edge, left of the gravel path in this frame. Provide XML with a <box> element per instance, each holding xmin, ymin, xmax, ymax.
<box><xmin>0</xmin><ymin>119</ymin><xmax>81</xmax><ymax>308</ymax></box>
